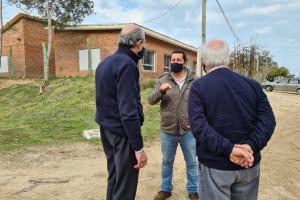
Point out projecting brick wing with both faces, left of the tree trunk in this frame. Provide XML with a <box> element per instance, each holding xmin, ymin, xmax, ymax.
<box><xmin>0</xmin><ymin>18</ymin><xmax>55</xmax><ymax>77</ymax></box>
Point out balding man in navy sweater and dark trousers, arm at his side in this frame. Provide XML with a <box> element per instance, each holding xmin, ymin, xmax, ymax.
<box><xmin>95</xmin><ymin>24</ymin><xmax>148</xmax><ymax>200</ymax></box>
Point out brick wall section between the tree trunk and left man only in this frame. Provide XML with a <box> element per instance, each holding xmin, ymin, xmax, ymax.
<box><xmin>55</xmin><ymin>31</ymin><xmax>120</xmax><ymax>76</ymax></box>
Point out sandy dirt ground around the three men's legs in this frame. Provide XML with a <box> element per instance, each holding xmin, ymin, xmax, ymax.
<box><xmin>0</xmin><ymin>92</ymin><xmax>300</xmax><ymax>200</ymax></box>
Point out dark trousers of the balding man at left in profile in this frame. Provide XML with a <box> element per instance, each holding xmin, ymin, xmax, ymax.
<box><xmin>100</xmin><ymin>127</ymin><xmax>139</xmax><ymax>200</ymax></box>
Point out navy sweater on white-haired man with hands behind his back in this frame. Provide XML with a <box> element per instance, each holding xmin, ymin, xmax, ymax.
<box><xmin>188</xmin><ymin>68</ymin><xmax>276</xmax><ymax>170</ymax></box>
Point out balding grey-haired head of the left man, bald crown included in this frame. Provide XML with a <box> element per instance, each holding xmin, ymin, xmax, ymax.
<box><xmin>119</xmin><ymin>24</ymin><xmax>145</xmax><ymax>49</ymax></box>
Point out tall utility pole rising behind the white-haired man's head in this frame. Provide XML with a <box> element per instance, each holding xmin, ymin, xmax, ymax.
<box><xmin>196</xmin><ymin>0</ymin><xmax>206</xmax><ymax>77</ymax></box>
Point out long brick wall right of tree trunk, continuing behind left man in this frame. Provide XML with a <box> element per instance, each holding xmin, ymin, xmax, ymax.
<box><xmin>55</xmin><ymin>30</ymin><xmax>197</xmax><ymax>79</ymax></box>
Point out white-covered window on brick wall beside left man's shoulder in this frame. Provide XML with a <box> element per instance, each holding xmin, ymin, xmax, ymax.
<box><xmin>79</xmin><ymin>49</ymin><xmax>100</xmax><ymax>71</ymax></box>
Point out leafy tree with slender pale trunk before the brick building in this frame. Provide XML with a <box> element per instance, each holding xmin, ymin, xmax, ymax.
<box><xmin>7</xmin><ymin>0</ymin><xmax>95</xmax><ymax>82</ymax></box>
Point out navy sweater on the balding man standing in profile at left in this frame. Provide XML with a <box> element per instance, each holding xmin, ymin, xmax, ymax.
<box><xmin>95</xmin><ymin>46</ymin><xmax>144</xmax><ymax>151</ymax></box>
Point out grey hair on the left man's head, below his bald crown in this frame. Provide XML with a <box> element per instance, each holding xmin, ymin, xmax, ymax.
<box><xmin>119</xmin><ymin>27</ymin><xmax>145</xmax><ymax>49</ymax></box>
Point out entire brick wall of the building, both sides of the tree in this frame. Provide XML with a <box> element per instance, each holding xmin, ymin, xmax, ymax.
<box><xmin>0</xmin><ymin>15</ymin><xmax>197</xmax><ymax>79</ymax></box>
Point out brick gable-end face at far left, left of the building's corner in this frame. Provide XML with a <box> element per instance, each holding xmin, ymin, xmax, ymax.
<box><xmin>0</xmin><ymin>19</ymin><xmax>26</xmax><ymax>77</ymax></box>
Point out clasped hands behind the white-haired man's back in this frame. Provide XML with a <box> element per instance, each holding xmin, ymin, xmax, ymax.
<box><xmin>229</xmin><ymin>147</ymin><xmax>254</xmax><ymax>168</ymax></box>
